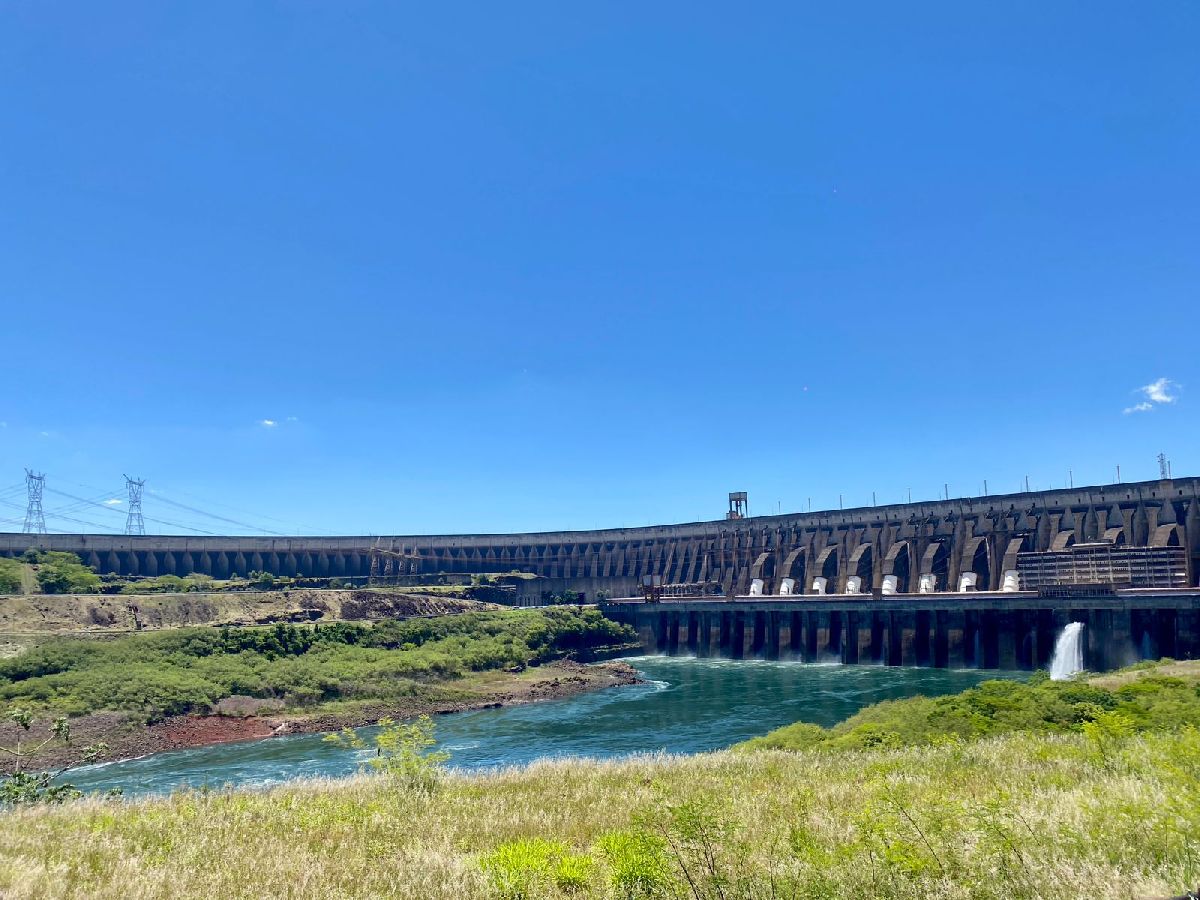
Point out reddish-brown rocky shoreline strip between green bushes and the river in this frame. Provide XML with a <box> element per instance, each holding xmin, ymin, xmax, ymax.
<box><xmin>0</xmin><ymin>660</ymin><xmax>642</xmax><ymax>772</ymax></box>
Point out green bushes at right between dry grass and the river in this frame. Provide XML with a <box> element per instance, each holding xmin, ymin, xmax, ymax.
<box><xmin>740</xmin><ymin>661</ymin><xmax>1200</xmax><ymax>752</ymax></box>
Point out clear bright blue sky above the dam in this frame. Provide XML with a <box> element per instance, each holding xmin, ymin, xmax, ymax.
<box><xmin>0</xmin><ymin>0</ymin><xmax>1200</xmax><ymax>533</ymax></box>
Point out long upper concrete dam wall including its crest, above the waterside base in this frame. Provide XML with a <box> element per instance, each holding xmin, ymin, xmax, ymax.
<box><xmin>0</xmin><ymin>478</ymin><xmax>1200</xmax><ymax>600</ymax></box>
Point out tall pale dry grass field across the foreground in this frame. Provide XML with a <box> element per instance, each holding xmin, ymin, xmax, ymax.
<box><xmin>0</xmin><ymin>730</ymin><xmax>1200</xmax><ymax>900</ymax></box>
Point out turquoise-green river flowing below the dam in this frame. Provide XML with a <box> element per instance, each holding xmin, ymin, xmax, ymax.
<box><xmin>70</xmin><ymin>656</ymin><xmax>1024</xmax><ymax>796</ymax></box>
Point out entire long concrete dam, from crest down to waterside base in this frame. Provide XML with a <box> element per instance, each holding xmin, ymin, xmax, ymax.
<box><xmin>9</xmin><ymin>478</ymin><xmax>1200</xmax><ymax>667</ymax></box>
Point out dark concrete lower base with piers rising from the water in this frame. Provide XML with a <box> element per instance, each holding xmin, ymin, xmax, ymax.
<box><xmin>609</xmin><ymin>588</ymin><xmax>1200</xmax><ymax>671</ymax></box>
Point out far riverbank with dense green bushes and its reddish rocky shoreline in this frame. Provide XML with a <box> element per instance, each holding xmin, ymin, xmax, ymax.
<box><xmin>0</xmin><ymin>607</ymin><xmax>636</xmax><ymax>769</ymax></box>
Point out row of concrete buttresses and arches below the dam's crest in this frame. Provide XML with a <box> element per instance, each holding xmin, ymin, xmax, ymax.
<box><xmin>4</xmin><ymin>484</ymin><xmax>1200</xmax><ymax>594</ymax></box>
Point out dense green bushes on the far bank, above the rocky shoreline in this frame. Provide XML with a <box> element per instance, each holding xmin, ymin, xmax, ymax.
<box><xmin>0</xmin><ymin>608</ymin><xmax>634</xmax><ymax>720</ymax></box>
